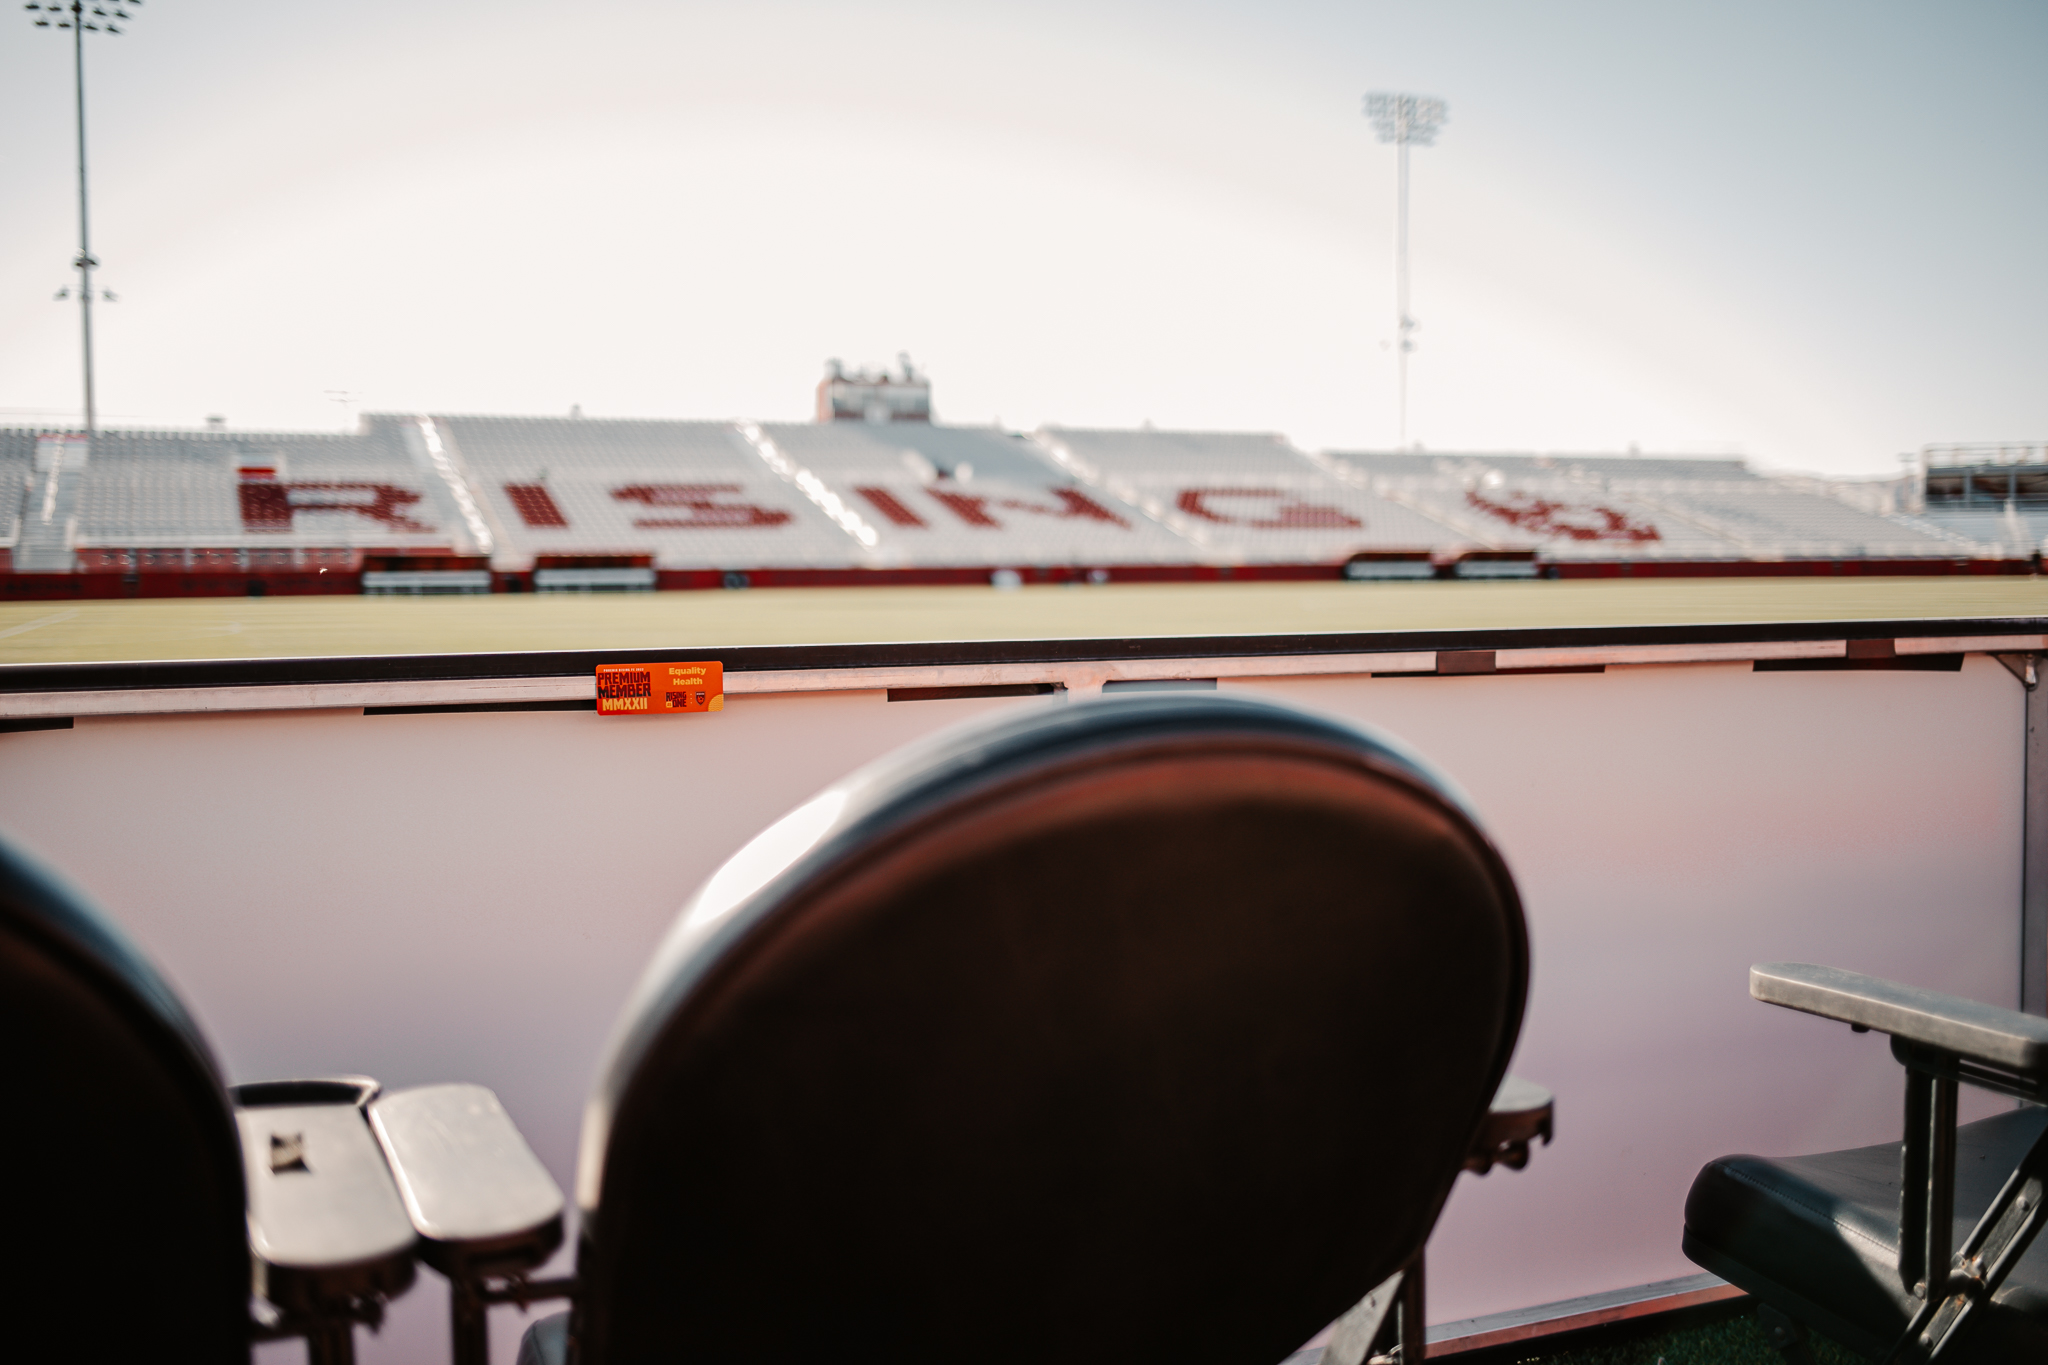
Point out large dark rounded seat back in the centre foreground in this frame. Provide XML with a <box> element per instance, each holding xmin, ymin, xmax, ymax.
<box><xmin>578</xmin><ymin>694</ymin><xmax>1528</xmax><ymax>1365</ymax></box>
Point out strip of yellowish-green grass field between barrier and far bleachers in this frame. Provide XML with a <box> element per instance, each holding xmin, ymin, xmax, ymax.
<box><xmin>0</xmin><ymin>577</ymin><xmax>2048</xmax><ymax>663</ymax></box>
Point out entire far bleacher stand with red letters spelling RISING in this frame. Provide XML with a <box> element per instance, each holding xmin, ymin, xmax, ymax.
<box><xmin>0</xmin><ymin>415</ymin><xmax>2015</xmax><ymax>589</ymax></box>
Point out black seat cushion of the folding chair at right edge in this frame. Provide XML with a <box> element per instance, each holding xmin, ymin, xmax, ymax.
<box><xmin>1686</xmin><ymin>1109</ymin><xmax>2048</xmax><ymax>1361</ymax></box>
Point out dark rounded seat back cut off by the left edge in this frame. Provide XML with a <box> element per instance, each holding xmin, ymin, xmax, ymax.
<box><xmin>0</xmin><ymin>843</ymin><xmax>250</xmax><ymax>1361</ymax></box>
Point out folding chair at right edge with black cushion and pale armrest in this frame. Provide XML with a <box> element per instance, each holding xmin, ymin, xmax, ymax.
<box><xmin>1683</xmin><ymin>962</ymin><xmax>2048</xmax><ymax>1361</ymax></box>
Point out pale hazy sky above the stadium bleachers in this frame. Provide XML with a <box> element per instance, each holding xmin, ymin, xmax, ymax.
<box><xmin>0</xmin><ymin>0</ymin><xmax>2048</xmax><ymax>473</ymax></box>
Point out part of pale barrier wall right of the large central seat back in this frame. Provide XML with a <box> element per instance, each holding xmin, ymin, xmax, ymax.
<box><xmin>1228</xmin><ymin>657</ymin><xmax>2025</xmax><ymax>1322</ymax></box>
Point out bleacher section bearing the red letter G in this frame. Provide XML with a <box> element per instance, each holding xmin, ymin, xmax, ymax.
<box><xmin>1034</xmin><ymin>428</ymin><xmax>1468</xmax><ymax>563</ymax></box>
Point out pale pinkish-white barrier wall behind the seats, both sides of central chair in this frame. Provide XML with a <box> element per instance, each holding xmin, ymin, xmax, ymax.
<box><xmin>0</xmin><ymin>655</ymin><xmax>2023</xmax><ymax>1363</ymax></box>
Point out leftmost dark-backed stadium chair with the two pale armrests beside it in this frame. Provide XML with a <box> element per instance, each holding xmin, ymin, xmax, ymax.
<box><xmin>0</xmin><ymin>845</ymin><xmax>561</xmax><ymax>1365</ymax></box>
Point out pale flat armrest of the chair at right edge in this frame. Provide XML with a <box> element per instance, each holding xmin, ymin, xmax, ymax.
<box><xmin>1749</xmin><ymin>962</ymin><xmax>2048</xmax><ymax>1083</ymax></box>
